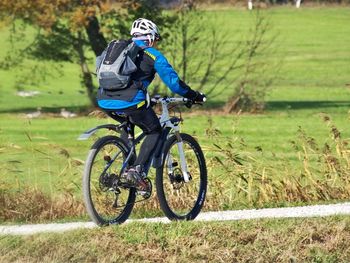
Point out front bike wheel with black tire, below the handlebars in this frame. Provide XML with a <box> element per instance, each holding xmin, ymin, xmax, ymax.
<box><xmin>156</xmin><ymin>133</ymin><xmax>208</xmax><ymax>220</ymax></box>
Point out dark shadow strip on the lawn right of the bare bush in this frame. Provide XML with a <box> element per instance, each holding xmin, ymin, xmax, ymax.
<box><xmin>266</xmin><ymin>101</ymin><xmax>350</xmax><ymax>111</ymax></box>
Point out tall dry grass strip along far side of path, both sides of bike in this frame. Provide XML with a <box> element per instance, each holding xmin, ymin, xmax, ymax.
<box><xmin>0</xmin><ymin>115</ymin><xmax>350</xmax><ymax>222</ymax></box>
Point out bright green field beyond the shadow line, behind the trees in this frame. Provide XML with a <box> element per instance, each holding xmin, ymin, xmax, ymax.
<box><xmin>0</xmin><ymin>7</ymin><xmax>350</xmax><ymax>112</ymax></box>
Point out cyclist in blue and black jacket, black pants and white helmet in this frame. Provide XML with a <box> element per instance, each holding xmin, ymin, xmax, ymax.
<box><xmin>97</xmin><ymin>18</ymin><xmax>205</xmax><ymax>189</ymax></box>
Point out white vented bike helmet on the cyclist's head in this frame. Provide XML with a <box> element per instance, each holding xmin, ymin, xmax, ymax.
<box><xmin>130</xmin><ymin>18</ymin><xmax>160</xmax><ymax>42</ymax></box>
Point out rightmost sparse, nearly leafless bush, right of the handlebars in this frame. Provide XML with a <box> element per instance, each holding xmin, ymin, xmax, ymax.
<box><xmin>224</xmin><ymin>9</ymin><xmax>282</xmax><ymax>113</ymax></box>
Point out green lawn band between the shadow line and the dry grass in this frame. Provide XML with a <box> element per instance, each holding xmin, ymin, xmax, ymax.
<box><xmin>0</xmin><ymin>111</ymin><xmax>350</xmax><ymax>189</ymax></box>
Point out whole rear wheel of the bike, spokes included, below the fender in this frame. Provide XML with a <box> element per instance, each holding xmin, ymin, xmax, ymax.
<box><xmin>83</xmin><ymin>136</ymin><xmax>136</xmax><ymax>226</ymax></box>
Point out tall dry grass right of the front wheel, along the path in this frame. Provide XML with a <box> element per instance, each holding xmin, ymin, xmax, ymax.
<box><xmin>207</xmin><ymin>115</ymin><xmax>350</xmax><ymax>209</ymax></box>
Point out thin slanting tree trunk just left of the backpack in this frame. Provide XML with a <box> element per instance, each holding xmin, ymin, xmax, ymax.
<box><xmin>74</xmin><ymin>32</ymin><xmax>97</xmax><ymax>106</ymax></box>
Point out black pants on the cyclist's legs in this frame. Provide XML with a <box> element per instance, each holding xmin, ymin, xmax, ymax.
<box><xmin>107</xmin><ymin>106</ymin><xmax>162</xmax><ymax>166</ymax></box>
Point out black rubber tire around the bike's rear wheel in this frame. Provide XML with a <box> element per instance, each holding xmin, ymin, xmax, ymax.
<box><xmin>83</xmin><ymin>136</ymin><xmax>136</xmax><ymax>226</ymax></box>
